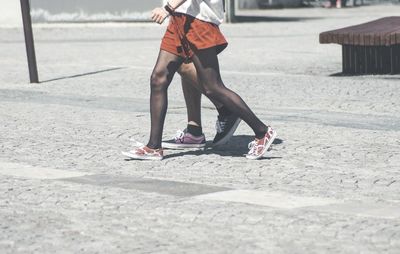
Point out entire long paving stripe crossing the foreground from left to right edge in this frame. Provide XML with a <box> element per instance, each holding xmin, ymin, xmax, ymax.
<box><xmin>0</xmin><ymin>161</ymin><xmax>400</xmax><ymax>219</ymax></box>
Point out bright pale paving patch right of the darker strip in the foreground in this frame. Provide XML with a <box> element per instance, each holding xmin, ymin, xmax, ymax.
<box><xmin>196</xmin><ymin>190</ymin><xmax>343</xmax><ymax>209</ymax></box>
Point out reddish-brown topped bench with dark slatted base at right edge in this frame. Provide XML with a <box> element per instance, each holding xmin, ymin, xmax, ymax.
<box><xmin>319</xmin><ymin>17</ymin><xmax>400</xmax><ymax>75</ymax></box>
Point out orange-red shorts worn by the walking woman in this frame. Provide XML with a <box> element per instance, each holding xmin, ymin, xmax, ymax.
<box><xmin>160</xmin><ymin>13</ymin><xmax>228</xmax><ymax>59</ymax></box>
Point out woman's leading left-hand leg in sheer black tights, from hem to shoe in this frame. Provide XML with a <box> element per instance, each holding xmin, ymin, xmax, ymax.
<box><xmin>147</xmin><ymin>50</ymin><xmax>183</xmax><ymax>149</ymax></box>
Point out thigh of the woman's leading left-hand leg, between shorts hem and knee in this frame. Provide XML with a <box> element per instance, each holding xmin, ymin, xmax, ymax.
<box><xmin>152</xmin><ymin>50</ymin><xmax>184</xmax><ymax>81</ymax></box>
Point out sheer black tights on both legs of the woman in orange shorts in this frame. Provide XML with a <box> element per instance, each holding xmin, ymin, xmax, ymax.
<box><xmin>147</xmin><ymin>48</ymin><xmax>268</xmax><ymax>149</ymax></box>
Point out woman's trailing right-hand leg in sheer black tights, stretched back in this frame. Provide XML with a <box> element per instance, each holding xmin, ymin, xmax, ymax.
<box><xmin>193</xmin><ymin>48</ymin><xmax>268</xmax><ymax>138</ymax></box>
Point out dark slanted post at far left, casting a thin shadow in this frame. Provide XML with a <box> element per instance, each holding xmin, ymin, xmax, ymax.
<box><xmin>21</xmin><ymin>0</ymin><xmax>39</xmax><ymax>83</ymax></box>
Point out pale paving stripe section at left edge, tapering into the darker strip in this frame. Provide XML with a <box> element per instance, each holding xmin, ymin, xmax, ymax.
<box><xmin>0</xmin><ymin>162</ymin><xmax>89</xmax><ymax>179</ymax></box>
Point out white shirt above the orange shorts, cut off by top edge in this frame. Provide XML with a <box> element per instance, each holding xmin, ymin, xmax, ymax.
<box><xmin>175</xmin><ymin>0</ymin><xmax>224</xmax><ymax>25</ymax></box>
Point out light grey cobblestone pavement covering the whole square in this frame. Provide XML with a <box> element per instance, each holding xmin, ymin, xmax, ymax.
<box><xmin>0</xmin><ymin>5</ymin><xmax>400</xmax><ymax>253</ymax></box>
